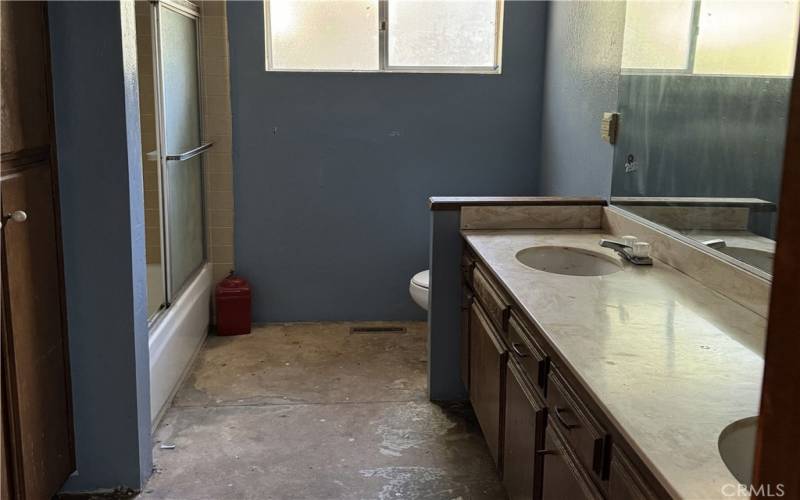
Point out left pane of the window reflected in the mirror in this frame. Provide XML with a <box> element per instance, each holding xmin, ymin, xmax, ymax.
<box><xmin>622</xmin><ymin>0</ymin><xmax>693</xmax><ymax>70</ymax></box>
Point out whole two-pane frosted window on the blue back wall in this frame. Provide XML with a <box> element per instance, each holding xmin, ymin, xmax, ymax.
<box><xmin>264</xmin><ymin>0</ymin><xmax>503</xmax><ymax>73</ymax></box>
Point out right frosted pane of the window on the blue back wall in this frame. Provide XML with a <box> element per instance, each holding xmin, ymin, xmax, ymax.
<box><xmin>388</xmin><ymin>0</ymin><xmax>498</xmax><ymax>68</ymax></box>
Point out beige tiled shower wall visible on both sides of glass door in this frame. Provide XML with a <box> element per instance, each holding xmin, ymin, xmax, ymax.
<box><xmin>136</xmin><ymin>1</ymin><xmax>233</xmax><ymax>282</ymax></box>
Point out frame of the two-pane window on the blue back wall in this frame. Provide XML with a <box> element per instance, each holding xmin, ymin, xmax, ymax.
<box><xmin>262</xmin><ymin>0</ymin><xmax>505</xmax><ymax>75</ymax></box>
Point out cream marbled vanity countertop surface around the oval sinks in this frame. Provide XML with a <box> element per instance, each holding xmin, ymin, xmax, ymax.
<box><xmin>462</xmin><ymin>229</ymin><xmax>766</xmax><ymax>498</ymax></box>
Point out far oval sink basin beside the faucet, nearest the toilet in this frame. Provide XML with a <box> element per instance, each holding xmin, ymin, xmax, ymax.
<box><xmin>517</xmin><ymin>246</ymin><xmax>622</xmax><ymax>276</ymax></box>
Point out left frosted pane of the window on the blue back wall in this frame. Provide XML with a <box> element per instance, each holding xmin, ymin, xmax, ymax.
<box><xmin>267</xmin><ymin>0</ymin><xmax>379</xmax><ymax>71</ymax></box>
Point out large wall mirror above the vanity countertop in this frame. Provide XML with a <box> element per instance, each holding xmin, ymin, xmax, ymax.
<box><xmin>611</xmin><ymin>0</ymin><xmax>800</xmax><ymax>277</ymax></box>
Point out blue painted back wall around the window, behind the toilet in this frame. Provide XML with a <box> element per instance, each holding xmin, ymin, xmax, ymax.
<box><xmin>228</xmin><ymin>2</ymin><xmax>547</xmax><ymax>322</ymax></box>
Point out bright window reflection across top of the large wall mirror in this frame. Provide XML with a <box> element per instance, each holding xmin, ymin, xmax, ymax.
<box><xmin>622</xmin><ymin>0</ymin><xmax>800</xmax><ymax>77</ymax></box>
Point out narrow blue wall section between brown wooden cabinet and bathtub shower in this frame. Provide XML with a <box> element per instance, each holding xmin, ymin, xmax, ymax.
<box><xmin>48</xmin><ymin>0</ymin><xmax>152</xmax><ymax>492</ymax></box>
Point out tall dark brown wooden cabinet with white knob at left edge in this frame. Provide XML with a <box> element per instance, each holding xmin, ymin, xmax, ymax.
<box><xmin>0</xmin><ymin>2</ymin><xmax>75</xmax><ymax>500</ymax></box>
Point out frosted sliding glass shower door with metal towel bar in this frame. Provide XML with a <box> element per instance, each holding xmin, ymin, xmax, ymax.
<box><xmin>148</xmin><ymin>0</ymin><xmax>211</xmax><ymax>320</ymax></box>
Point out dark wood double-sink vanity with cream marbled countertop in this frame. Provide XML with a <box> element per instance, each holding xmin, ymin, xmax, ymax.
<box><xmin>460</xmin><ymin>206</ymin><xmax>766</xmax><ymax>499</ymax></box>
